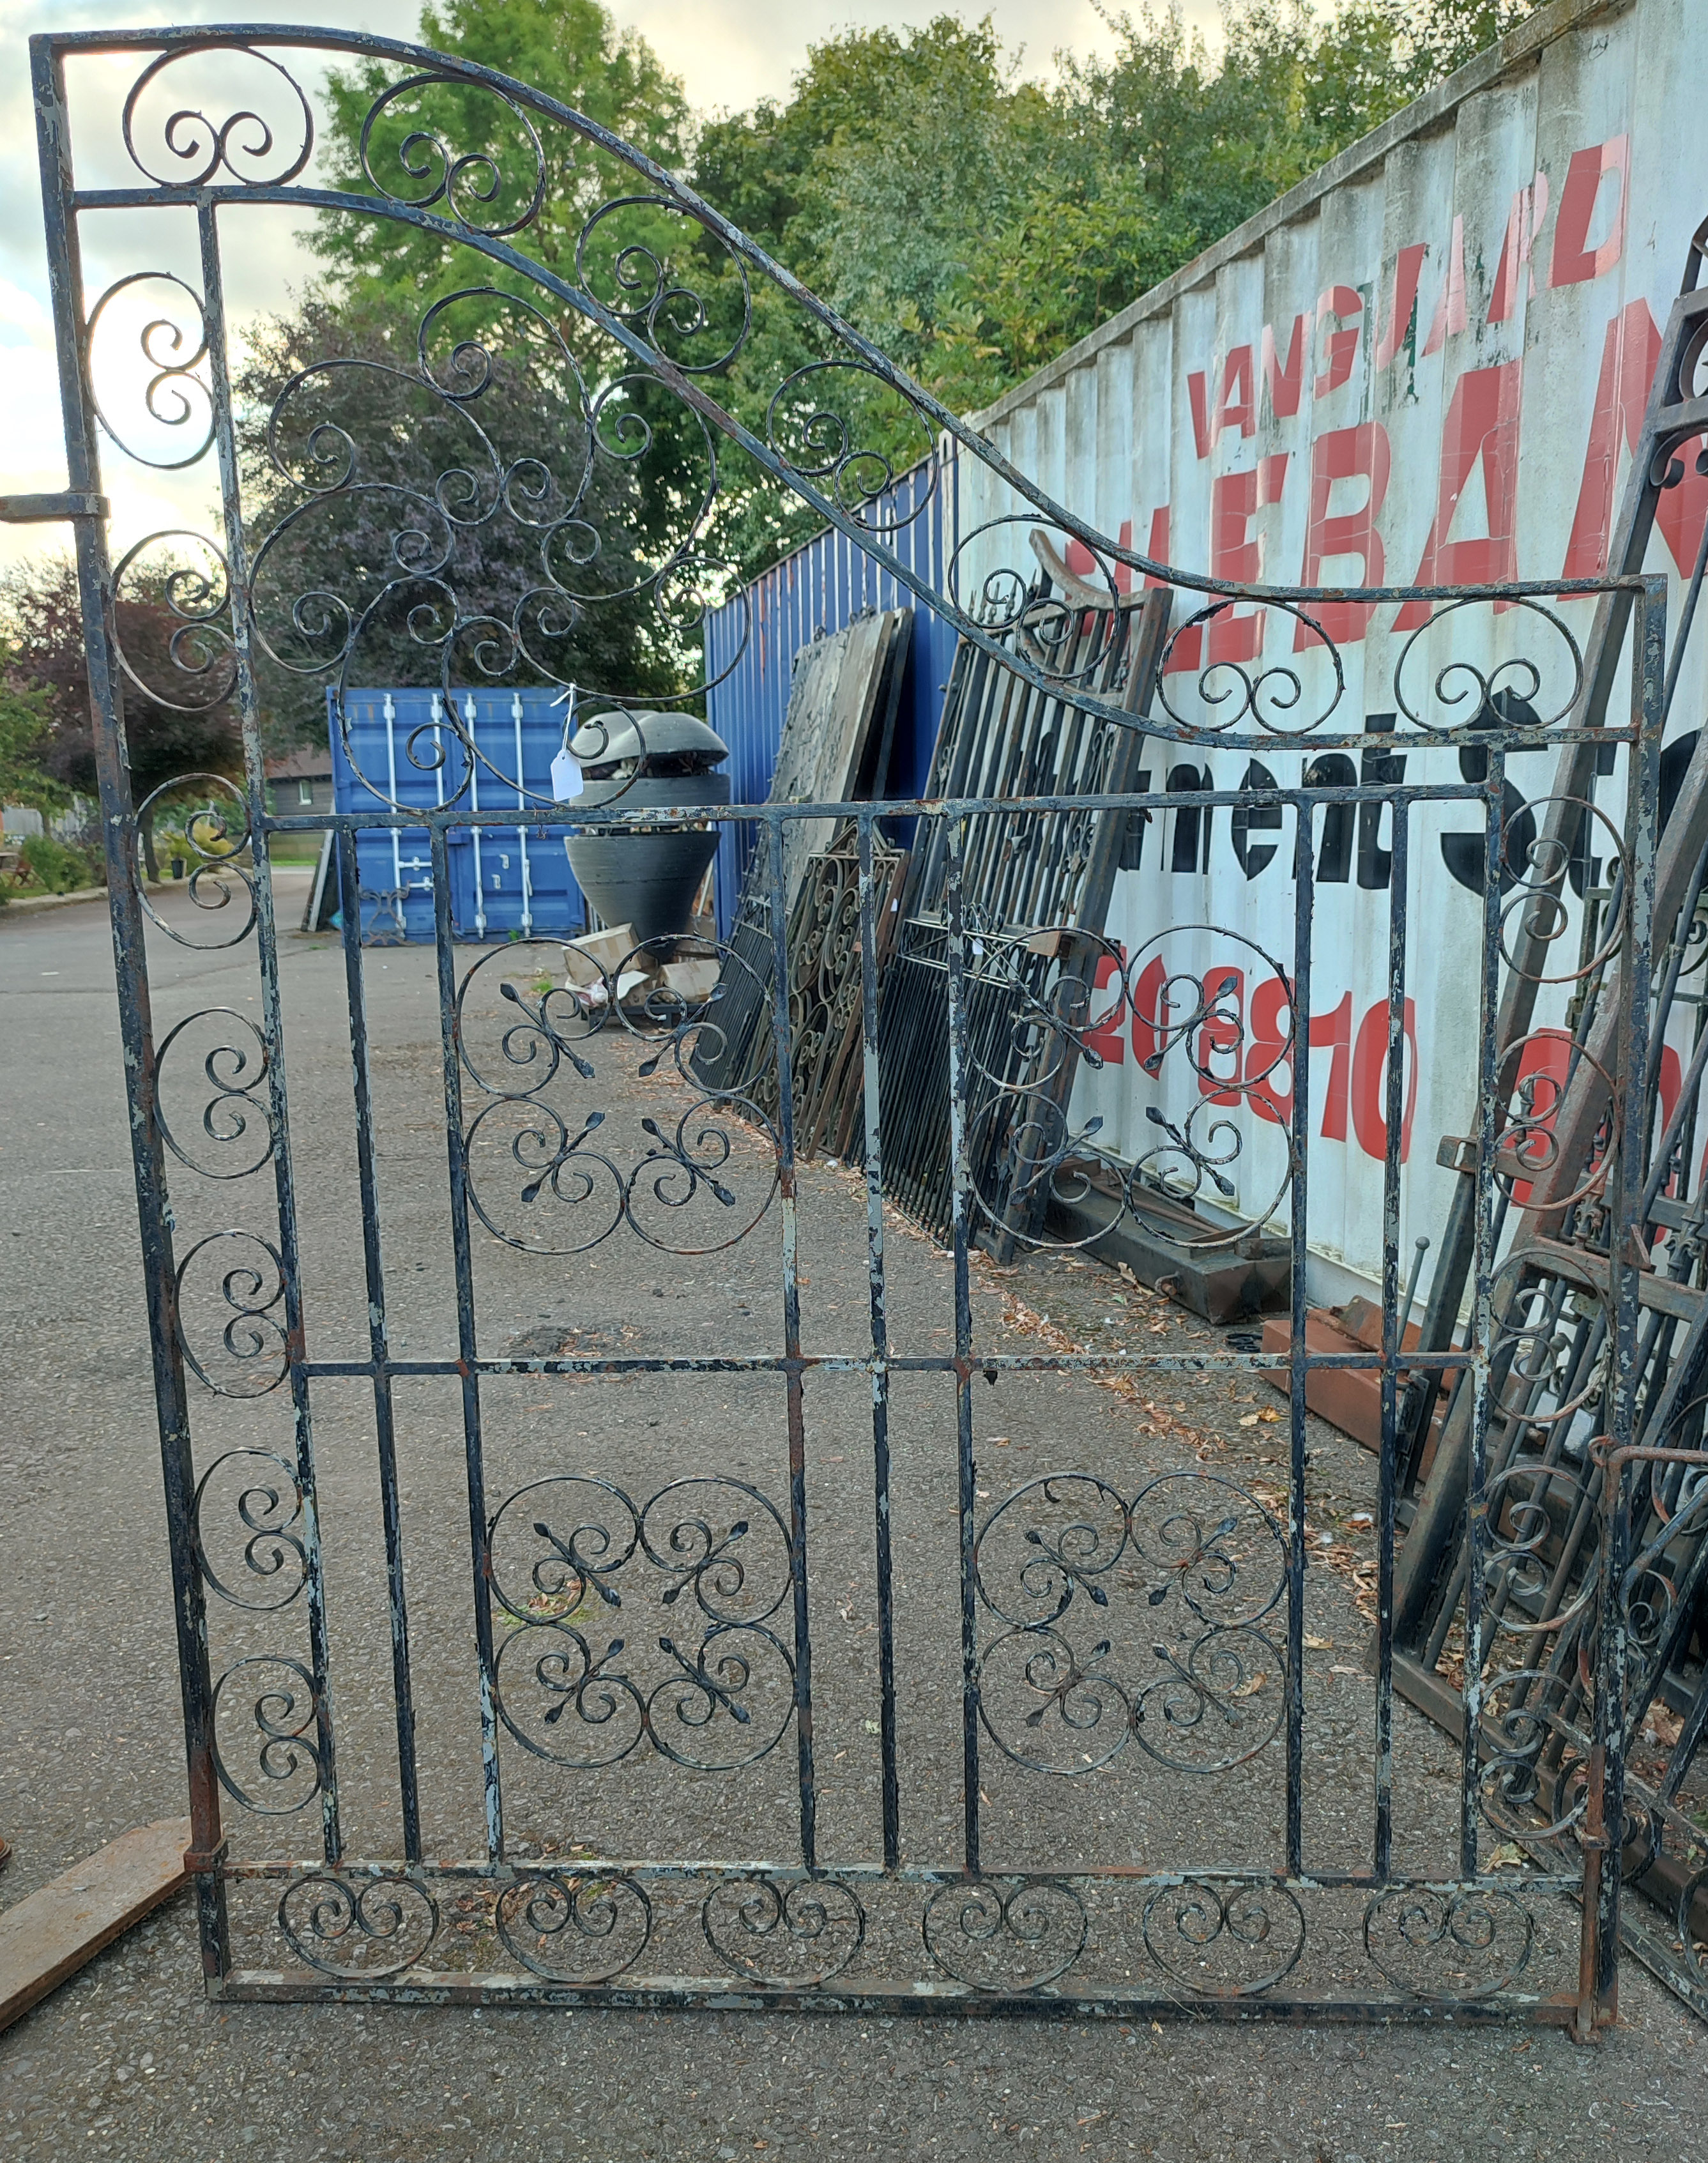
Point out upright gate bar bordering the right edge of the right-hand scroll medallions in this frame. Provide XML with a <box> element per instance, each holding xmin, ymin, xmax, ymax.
<box><xmin>1286</xmin><ymin>796</ymin><xmax>1316</xmax><ymax>1877</ymax></box>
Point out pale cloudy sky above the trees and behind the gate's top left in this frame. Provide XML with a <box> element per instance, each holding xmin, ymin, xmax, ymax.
<box><xmin>0</xmin><ymin>0</ymin><xmax>1217</xmax><ymax>560</ymax></box>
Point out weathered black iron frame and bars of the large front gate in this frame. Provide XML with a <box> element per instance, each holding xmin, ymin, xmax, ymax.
<box><xmin>4</xmin><ymin>26</ymin><xmax>1667</xmax><ymax>2040</ymax></box>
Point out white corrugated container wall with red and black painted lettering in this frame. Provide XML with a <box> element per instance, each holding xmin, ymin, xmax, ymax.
<box><xmin>957</xmin><ymin>0</ymin><xmax>1708</xmax><ymax>1294</ymax></box>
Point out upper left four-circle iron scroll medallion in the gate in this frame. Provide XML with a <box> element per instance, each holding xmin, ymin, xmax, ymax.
<box><xmin>456</xmin><ymin>939</ymin><xmax>781</xmax><ymax>1255</ymax></box>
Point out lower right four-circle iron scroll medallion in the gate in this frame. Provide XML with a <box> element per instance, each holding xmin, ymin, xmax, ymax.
<box><xmin>973</xmin><ymin>1473</ymin><xmax>1286</xmax><ymax>1778</ymax></box>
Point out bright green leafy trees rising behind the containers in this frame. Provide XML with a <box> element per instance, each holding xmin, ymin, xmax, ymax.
<box><xmin>300</xmin><ymin>0</ymin><xmax>1539</xmax><ymax>573</ymax></box>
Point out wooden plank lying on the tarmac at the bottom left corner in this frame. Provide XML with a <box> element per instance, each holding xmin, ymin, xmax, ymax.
<box><xmin>0</xmin><ymin>1817</ymin><xmax>190</xmax><ymax>2029</ymax></box>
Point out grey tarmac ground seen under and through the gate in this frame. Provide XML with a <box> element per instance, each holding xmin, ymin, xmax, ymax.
<box><xmin>0</xmin><ymin>874</ymin><xmax>1708</xmax><ymax>2163</ymax></box>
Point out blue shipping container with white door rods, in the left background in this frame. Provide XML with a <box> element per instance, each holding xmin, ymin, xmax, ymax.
<box><xmin>326</xmin><ymin>688</ymin><xmax>588</xmax><ymax>939</ymax></box>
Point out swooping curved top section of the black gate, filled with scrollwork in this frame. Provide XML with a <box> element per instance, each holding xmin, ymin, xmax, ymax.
<box><xmin>30</xmin><ymin>26</ymin><xmax>1669</xmax><ymax>802</ymax></box>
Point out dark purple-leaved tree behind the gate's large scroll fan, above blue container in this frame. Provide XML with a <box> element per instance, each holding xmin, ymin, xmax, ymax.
<box><xmin>236</xmin><ymin>292</ymin><xmax>687</xmax><ymax>746</ymax></box>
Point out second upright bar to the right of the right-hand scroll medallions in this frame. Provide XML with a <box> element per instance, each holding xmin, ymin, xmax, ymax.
<box><xmin>1373</xmin><ymin>796</ymin><xmax>1422</xmax><ymax>1879</ymax></box>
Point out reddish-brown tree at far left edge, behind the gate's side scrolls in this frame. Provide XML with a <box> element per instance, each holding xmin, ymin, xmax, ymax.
<box><xmin>0</xmin><ymin>556</ymin><xmax>242</xmax><ymax>878</ymax></box>
